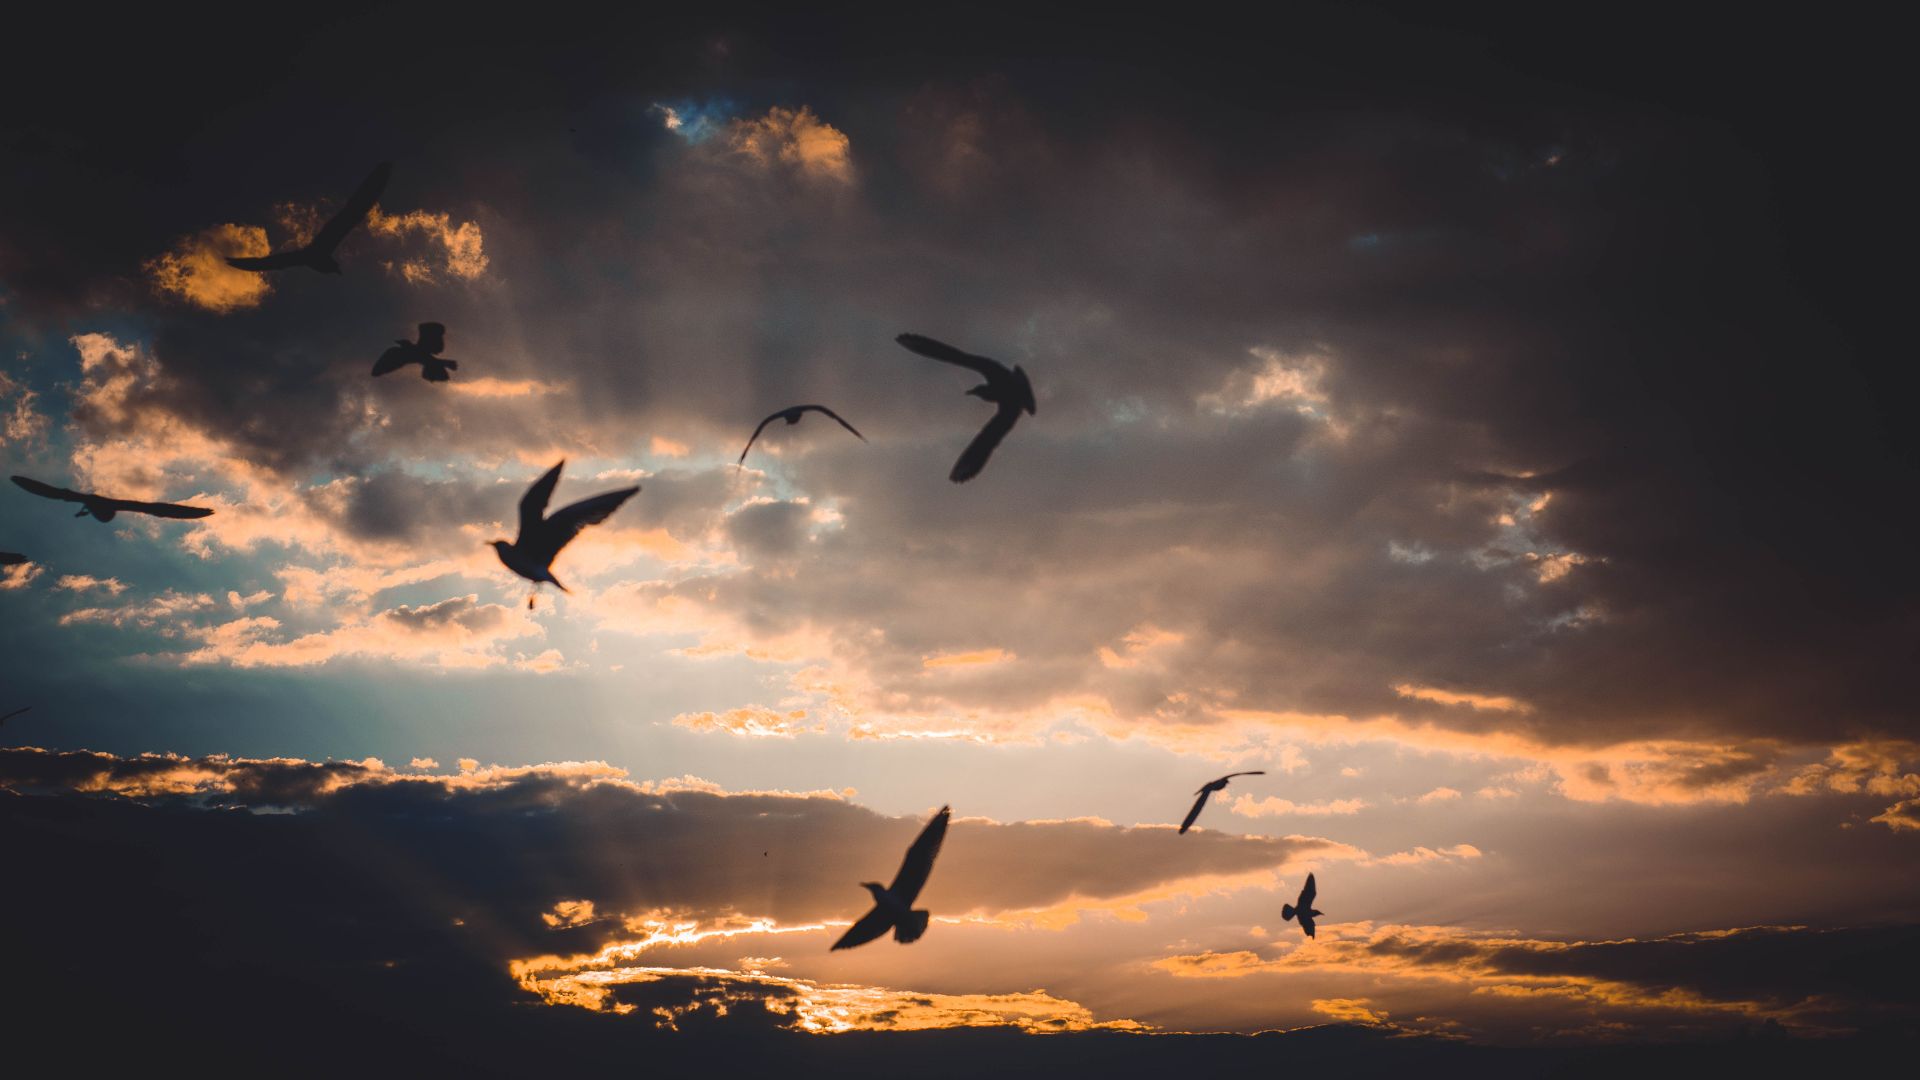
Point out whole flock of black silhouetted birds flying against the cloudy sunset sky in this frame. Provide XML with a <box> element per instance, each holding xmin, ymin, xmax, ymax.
<box><xmin>0</xmin><ymin>161</ymin><xmax>1321</xmax><ymax>951</ymax></box>
